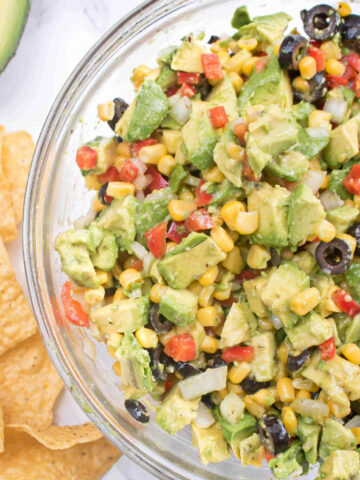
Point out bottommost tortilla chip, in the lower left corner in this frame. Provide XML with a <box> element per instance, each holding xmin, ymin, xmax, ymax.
<box><xmin>0</xmin><ymin>428</ymin><xmax>121</xmax><ymax>480</ymax></box>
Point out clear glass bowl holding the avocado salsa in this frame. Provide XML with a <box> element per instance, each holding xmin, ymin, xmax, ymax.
<box><xmin>23</xmin><ymin>0</ymin><xmax>344</xmax><ymax>480</ymax></box>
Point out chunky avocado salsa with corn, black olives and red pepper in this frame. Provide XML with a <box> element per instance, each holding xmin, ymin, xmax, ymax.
<box><xmin>55</xmin><ymin>2</ymin><xmax>360</xmax><ymax>480</ymax></box>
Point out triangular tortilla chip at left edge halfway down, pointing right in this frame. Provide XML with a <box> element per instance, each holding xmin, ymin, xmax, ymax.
<box><xmin>0</xmin><ymin>238</ymin><xmax>37</xmax><ymax>358</ymax></box>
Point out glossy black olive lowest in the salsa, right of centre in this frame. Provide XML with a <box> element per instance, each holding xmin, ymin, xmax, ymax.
<box><xmin>257</xmin><ymin>415</ymin><xmax>290</xmax><ymax>455</ymax></box>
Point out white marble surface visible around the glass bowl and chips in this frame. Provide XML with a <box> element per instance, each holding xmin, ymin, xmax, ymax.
<box><xmin>0</xmin><ymin>0</ymin><xmax>154</xmax><ymax>480</ymax></box>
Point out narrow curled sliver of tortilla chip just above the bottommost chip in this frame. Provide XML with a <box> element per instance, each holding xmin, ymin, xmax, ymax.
<box><xmin>6</xmin><ymin>423</ymin><xmax>102</xmax><ymax>450</ymax></box>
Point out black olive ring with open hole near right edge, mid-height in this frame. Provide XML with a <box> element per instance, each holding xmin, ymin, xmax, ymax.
<box><xmin>315</xmin><ymin>238</ymin><xmax>352</xmax><ymax>275</ymax></box>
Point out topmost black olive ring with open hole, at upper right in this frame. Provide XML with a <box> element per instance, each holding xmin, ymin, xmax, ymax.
<box><xmin>300</xmin><ymin>5</ymin><xmax>341</xmax><ymax>41</ymax></box>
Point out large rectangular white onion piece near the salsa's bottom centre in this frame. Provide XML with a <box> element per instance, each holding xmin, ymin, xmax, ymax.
<box><xmin>179</xmin><ymin>365</ymin><xmax>227</xmax><ymax>400</ymax></box>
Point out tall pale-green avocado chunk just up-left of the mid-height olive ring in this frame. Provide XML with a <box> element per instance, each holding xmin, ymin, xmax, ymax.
<box><xmin>288</xmin><ymin>183</ymin><xmax>326</xmax><ymax>248</ymax></box>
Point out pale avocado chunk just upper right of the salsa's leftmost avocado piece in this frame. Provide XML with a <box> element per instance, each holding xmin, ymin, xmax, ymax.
<box><xmin>96</xmin><ymin>195</ymin><xmax>139</xmax><ymax>250</ymax></box>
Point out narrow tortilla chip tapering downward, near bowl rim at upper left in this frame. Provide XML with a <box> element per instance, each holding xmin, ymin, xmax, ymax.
<box><xmin>2</xmin><ymin>131</ymin><xmax>35</xmax><ymax>223</ymax></box>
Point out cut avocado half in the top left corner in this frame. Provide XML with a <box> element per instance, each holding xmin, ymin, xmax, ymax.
<box><xmin>0</xmin><ymin>0</ymin><xmax>30</xmax><ymax>72</ymax></box>
